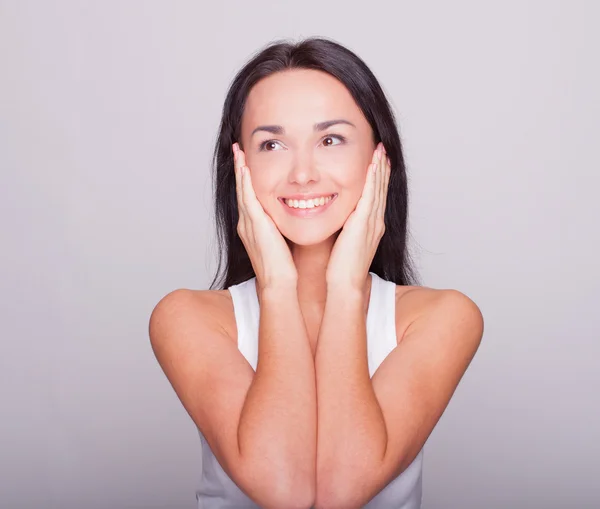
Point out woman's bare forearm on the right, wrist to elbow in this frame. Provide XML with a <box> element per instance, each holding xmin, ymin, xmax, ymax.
<box><xmin>315</xmin><ymin>291</ymin><xmax>387</xmax><ymax>507</ymax></box>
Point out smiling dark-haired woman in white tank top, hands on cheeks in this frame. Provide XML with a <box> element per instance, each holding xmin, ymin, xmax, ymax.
<box><xmin>150</xmin><ymin>38</ymin><xmax>483</xmax><ymax>509</ymax></box>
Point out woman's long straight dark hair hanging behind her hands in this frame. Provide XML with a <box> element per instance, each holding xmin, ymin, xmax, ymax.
<box><xmin>210</xmin><ymin>37</ymin><xmax>418</xmax><ymax>289</ymax></box>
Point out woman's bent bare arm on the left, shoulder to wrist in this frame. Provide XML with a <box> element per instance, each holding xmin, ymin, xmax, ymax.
<box><xmin>150</xmin><ymin>290</ymin><xmax>316</xmax><ymax>508</ymax></box>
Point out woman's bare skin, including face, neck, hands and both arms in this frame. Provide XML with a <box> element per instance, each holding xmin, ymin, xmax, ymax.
<box><xmin>150</xmin><ymin>71</ymin><xmax>483</xmax><ymax>509</ymax></box>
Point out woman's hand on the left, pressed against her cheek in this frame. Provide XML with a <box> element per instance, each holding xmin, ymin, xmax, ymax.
<box><xmin>233</xmin><ymin>143</ymin><xmax>298</xmax><ymax>291</ymax></box>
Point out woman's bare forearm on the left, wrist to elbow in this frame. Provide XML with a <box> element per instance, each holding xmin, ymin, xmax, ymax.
<box><xmin>238</xmin><ymin>287</ymin><xmax>317</xmax><ymax>507</ymax></box>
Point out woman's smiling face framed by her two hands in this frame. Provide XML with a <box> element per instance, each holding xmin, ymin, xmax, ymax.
<box><xmin>241</xmin><ymin>69</ymin><xmax>376</xmax><ymax>245</ymax></box>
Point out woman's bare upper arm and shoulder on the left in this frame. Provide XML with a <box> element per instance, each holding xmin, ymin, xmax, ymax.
<box><xmin>149</xmin><ymin>289</ymin><xmax>254</xmax><ymax>490</ymax></box>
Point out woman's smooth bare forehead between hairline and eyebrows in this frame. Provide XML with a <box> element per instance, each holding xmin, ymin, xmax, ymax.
<box><xmin>242</xmin><ymin>69</ymin><xmax>367</xmax><ymax>132</ymax></box>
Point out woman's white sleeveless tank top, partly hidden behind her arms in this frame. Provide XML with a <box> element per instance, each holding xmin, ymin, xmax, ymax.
<box><xmin>196</xmin><ymin>272</ymin><xmax>423</xmax><ymax>509</ymax></box>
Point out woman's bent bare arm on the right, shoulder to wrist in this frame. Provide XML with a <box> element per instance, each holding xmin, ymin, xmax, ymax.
<box><xmin>315</xmin><ymin>289</ymin><xmax>483</xmax><ymax>509</ymax></box>
